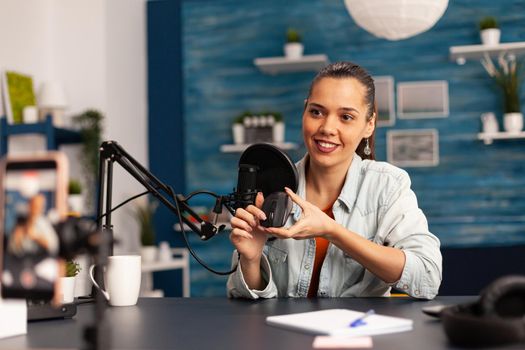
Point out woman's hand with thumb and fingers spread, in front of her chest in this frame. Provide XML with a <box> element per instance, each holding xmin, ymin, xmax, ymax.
<box><xmin>267</xmin><ymin>187</ymin><xmax>335</xmax><ymax>239</ymax></box>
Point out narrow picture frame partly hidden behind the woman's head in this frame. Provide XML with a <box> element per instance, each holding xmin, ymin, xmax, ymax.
<box><xmin>373</xmin><ymin>75</ymin><xmax>396</xmax><ymax>127</ymax></box>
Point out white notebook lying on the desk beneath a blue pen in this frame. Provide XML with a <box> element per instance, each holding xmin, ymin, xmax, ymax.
<box><xmin>266</xmin><ymin>309</ymin><xmax>413</xmax><ymax>336</ymax></box>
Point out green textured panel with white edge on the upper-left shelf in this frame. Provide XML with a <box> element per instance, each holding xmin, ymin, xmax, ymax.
<box><xmin>2</xmin><ymin>71</ymin><xmax>36</xmax><ymax>124</ymax></box>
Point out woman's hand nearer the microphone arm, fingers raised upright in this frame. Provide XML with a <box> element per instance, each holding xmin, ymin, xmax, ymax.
<box><xmin>230</xmin><ymin>192</ymin><xmax>268</xmax><ymax>265</ymax></box>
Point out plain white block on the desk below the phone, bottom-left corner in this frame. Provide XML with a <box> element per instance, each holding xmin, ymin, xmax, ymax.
<box><xmin>0</xmin><ymin>299</ymin><xmax>27</xmax><ymax>339</ymax></box>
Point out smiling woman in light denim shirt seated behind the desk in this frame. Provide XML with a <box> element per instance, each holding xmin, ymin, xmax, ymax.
<box><xmin>228</xmin><ymin>62</ymin><xmax>441</xmax><ymax>299</ymax></box>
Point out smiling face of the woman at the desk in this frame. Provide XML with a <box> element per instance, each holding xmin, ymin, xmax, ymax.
<box><xmin>303</xmin><ymin>78</ymin><xmax>375</xmax><ymax>169</ymax></box>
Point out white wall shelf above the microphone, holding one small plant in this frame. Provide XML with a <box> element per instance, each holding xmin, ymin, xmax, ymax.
<box><xmin>253</xmin><ymin>54</ymin><xmax>328</xmax><ymax>74</ymax></box>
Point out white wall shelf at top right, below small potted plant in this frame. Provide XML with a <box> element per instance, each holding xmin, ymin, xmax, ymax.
<box><xmin>449</xmin><ymin>41</ymin><xmax>525</xmax><ymax>64</ymax></box>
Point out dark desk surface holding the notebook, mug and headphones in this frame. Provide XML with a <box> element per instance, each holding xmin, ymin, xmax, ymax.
<box><xmin>0</xmin><ymin>297</ymin><xmax>523</xmax><ymax>350</ymax></box>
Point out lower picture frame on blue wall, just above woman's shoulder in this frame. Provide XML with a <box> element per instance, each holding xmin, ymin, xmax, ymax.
<box><xmin>387</xmin><ymin>129</ymin><xmax>439</xmax><ymax>167</ymax></box>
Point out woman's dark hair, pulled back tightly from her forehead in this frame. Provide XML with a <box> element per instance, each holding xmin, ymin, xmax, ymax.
<box><xmin>308</xmin><ymin>61</ymin><xmax>377</xmax><ymax>159</ymax></box>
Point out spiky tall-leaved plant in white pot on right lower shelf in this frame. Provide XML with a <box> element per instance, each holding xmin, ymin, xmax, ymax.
<box><xmin>481</xmin><ymin>54</ymin><xmax>523</xmax><ymax>133</ymax></box>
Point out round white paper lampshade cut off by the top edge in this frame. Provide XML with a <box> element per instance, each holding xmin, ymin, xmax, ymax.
<box><xmin>345</xmin><ymin>0</ymin><xmax>448</xmax><ymax>40</ymax></box>
